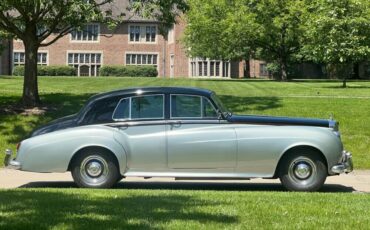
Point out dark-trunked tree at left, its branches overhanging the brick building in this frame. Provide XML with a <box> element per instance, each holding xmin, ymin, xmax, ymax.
<box><xmin>0</xmin><ymin>0</ymin><xmax>114</xmax><ymax>106</ymax></box>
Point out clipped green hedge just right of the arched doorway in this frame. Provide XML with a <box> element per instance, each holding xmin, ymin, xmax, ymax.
<box><xmin>100</xmin><ymin>65</ymin><xmax>158</xmax><ymax>77</ymax></box>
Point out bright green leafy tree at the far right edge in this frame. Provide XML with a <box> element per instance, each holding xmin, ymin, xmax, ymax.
<box><xmin>302</xmin><ymin>0</ymin><xmax>370</xmax><ymax>87</ymax></box>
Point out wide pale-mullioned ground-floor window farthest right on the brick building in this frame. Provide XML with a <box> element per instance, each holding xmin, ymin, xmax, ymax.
<box><xmin>189</xmin><ymin>58</ymin><xmax>230</xmax><ymax>77</ymax></box>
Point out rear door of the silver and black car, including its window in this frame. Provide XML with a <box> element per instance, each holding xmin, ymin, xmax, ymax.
<box><xmin>113</xmin><ymin>94</ymin><xmax>167</xmax><ymax>172</ymax></box>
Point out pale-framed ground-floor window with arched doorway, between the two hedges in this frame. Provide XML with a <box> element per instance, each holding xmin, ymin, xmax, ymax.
<box><xmin>67</xmin><ymin>53</ymin><xmax>102</xmax><ymax>76</ymax></box>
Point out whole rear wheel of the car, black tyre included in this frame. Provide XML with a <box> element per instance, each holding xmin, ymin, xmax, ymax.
<box><xmin>71</xmin><ymin>150</ymin><xmax>120</xmax><ymax>188</ymax></box>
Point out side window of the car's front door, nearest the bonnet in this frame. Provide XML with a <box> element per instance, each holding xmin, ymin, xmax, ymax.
<box><xmin>171</xmin><ymin>95</ymin><xmax>217</xmax><ymax>118</ymax></box>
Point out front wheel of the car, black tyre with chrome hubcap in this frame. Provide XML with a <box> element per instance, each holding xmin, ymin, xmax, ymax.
<box><xmin>279</xmin><ymin>150</ymin><xmax>327</xmax><ymax>192</ymax></box>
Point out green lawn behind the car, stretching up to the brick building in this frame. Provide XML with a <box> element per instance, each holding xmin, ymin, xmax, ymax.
<box><xmin>0</xmin><ymin>77</ymin><xmax>370</xmax><ymax>169</ymax></box>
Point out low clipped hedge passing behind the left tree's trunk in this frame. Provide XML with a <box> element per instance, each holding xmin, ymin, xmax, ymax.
<box><xmin>13</xmin><ymin>66</ymin><xmax>76</xmax><ymax>76</ymax></box>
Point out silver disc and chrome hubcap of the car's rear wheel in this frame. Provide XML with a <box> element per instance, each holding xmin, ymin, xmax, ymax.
<box><xmin>80</xmin><ymin>155</ymin><xmax>109</xmax><ymax>186</ymax></box>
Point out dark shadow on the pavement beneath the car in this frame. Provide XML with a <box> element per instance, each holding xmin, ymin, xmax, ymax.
<box><xmin>19</xmin><ymin>181</ymin><xmax>356</xmax><ymax>193</ymax></box>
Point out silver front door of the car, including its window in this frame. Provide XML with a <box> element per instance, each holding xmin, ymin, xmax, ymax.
<box><xmin>167</xmin><ymin>94</ymin><xmax>237</xmax><ymax>169</ymax></box>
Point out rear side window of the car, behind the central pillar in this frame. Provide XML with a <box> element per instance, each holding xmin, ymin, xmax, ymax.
<box><xmin>113</xmin><ymin>95</ymin><xmax>164</xmax><ymax>120</ymax></box>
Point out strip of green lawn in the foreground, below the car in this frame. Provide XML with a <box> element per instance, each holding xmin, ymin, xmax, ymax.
<box><xmin>0</xmin><ymin>187</ymin><xmax>370</xmax><ymax>230</ymax></box>
